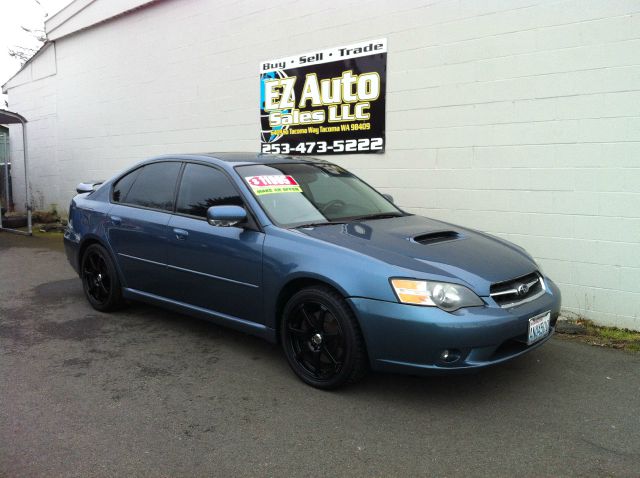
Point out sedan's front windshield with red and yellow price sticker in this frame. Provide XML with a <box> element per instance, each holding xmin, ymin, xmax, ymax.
<box><xmin>236</xmin><ymin>163</ymin><xmax>404</xmax><ymax>227</ymax></box>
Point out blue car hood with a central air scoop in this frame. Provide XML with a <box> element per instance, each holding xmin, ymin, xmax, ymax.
<box><xmin>299</xmin><ymin>215</ymin><xmax>537</xmax><ymax>296</ymax></box>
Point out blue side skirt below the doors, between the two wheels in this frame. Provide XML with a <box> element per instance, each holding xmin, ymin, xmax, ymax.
<box><xmin>122</xmin><ymin>287</ymin><xmax>277</xmax><ymax>343</ymax></box>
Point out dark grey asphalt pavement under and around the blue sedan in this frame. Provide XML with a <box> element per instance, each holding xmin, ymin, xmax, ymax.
<box><xmin>0</xmin><ymin>232</ymin><xmax>640</xmax><ymax>477</ymax></box>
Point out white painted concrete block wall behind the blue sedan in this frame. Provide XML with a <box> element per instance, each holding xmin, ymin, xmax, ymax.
<box><xmin>9</xmin><ymin>0</ymin><xmax>640</xmax><ymax>329</ymax></box>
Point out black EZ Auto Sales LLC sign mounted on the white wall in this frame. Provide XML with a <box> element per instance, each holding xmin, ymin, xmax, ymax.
<box><xmin>260</xmin><ymin>39</ymin><xmax>387</xmax><ymax>154</ymax></box>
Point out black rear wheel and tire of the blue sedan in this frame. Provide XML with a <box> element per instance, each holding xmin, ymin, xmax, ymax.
<box><xmin>80</xmin><ymin>244</ymin><xmax>124</xmax><ymax>312</ymax></box>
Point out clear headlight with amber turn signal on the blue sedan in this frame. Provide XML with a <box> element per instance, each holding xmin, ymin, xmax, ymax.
<box><xmin>391</xmin><ymin>279</ymin><xmax>484</xmax><ymax>312</ymax></box>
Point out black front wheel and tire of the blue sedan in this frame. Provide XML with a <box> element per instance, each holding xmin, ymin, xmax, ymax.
<box><xmin>280</xmin><ymin>286</ymin><xmax>368</xmax><ymax>390</ymax></box>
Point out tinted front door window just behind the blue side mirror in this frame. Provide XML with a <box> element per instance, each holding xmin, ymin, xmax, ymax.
<box><xmin>176</xmin><ymin>164</ymin><xmax>243</xmax><ymax>217</ymax></box>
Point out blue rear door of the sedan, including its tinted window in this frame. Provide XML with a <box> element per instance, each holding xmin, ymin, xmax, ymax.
<box><xmin>107</xmin><ymin>161</ymin><xmax>182</xmax><ymax>296</ymax></box>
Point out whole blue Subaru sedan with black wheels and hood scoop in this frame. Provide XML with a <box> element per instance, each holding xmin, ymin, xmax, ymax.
<box><xmin>64</xmin><ymin>153</ymin><xmax>560</xmax><ymax>389</ymax></box>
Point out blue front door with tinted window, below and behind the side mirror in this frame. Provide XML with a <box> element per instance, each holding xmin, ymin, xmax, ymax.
<box><xmin>168</xmin><ymin>163</ymin><xmax>264</xmax><ymax>322</ymax></box>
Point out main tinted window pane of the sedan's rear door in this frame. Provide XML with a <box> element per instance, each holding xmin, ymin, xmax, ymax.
<box><xmin>124</xmin><ymin>162</ymin><xmax>180</xmax><ymax>211</ymax></box>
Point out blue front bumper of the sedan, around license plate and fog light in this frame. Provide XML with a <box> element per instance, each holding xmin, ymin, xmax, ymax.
<box><xmin>349</xmin><ymin>278</ymin><xmax>561</xmax><ymax>374</ymax></box>
